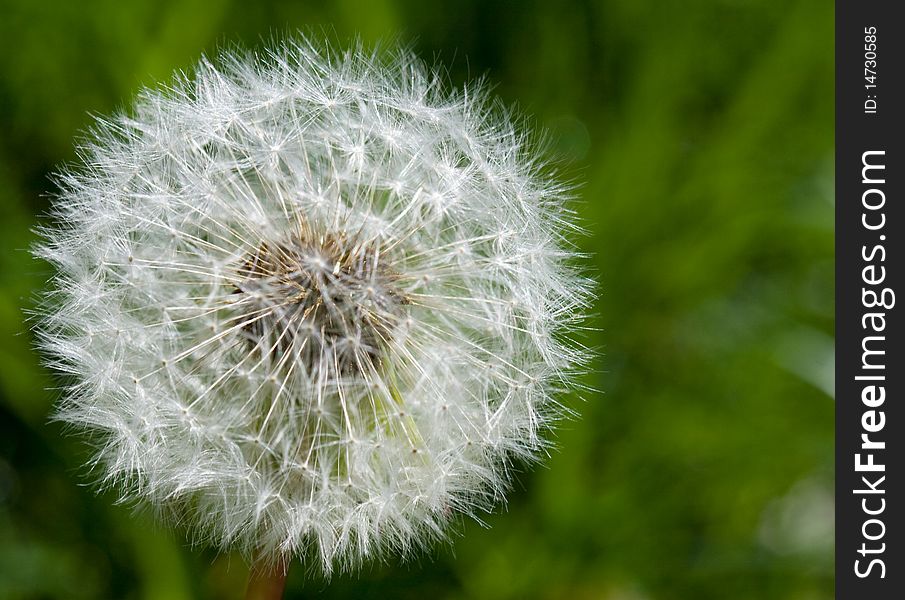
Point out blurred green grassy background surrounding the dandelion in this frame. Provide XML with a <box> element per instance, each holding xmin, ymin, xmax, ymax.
<box><xmin>0</xmin><ymin>0</ymin><xmax>834</xmax><ymax>600</ymax></box>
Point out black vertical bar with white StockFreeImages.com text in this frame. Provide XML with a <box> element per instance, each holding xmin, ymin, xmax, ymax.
<box><xmin>836</xmin><ymin>0</ymin><xmax>905</xmax><ymax>600</ymax></box>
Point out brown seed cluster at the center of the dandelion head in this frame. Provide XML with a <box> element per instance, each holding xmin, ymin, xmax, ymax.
<box><xmin>236</xmin><ymin>234</ymin><xmax>408</xmax><ymax>376</ymax></box>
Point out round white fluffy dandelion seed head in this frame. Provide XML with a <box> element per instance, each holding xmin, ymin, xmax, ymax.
<box><xmin>36</xmin><ymin>40</ymin><xmax>588</xmax><ymax>596</ymax></box>
